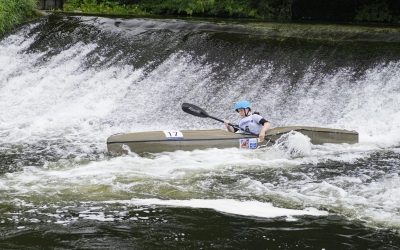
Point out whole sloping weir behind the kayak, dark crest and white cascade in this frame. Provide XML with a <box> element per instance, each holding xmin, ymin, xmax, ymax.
<box><xmin>0</xmin><ymin>16</ymin><xmax>400</xmax><ymax>147</ymax></box>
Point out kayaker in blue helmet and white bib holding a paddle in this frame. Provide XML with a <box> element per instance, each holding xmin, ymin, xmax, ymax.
<box><xmin>224</xmin><ymin>101</ymin><xmax>270</xmax><ymax>142</ymax></box>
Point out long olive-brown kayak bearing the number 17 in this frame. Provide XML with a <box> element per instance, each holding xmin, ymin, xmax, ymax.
<box><xmin>107</xmin><ymin>126</ymin><xmax>358</xmax><ymax>155</ymax></box>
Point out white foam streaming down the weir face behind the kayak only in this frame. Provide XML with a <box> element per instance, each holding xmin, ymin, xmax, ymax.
<box><xmin>0</xmin><ymin>23</ymin><xmax>400</xmax><ymax>146</ymax></box>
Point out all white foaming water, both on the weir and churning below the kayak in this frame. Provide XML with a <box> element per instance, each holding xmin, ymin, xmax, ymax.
<box><xmin>0</xmin><ymin>20</ymin><xmax>400</xmax><ymax>228</ymax></box>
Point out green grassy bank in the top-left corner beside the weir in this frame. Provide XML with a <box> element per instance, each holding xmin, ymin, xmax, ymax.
<box><xmin>0</xmin><ymin>0</ymin><xmax>37</xmax><ymax>36</ymax></box>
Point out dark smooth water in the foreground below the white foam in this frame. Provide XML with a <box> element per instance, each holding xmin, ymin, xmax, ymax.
<box><xmin>0</xmin><ymin>207</ymin><xmax>400</xmax><ymax>249</ymax></box>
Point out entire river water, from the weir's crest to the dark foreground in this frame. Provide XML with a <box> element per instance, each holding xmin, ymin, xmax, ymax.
<box><xmin>0</xmin><ymin>16</ymin><xmax>400</xmax><ymax>249</ymax></box>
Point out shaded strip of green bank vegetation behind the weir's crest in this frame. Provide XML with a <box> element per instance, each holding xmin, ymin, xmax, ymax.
<box><xmin>64</xmin><ymin>0</ymin><xmax>400</xmax><ymax>24</ymax></box>
